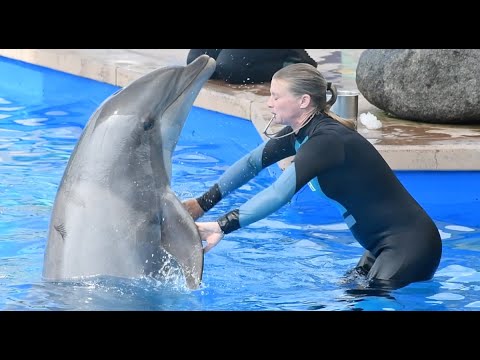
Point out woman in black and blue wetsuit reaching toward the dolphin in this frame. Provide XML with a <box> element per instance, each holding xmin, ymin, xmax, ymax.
<box><xmin>184</xmin><ymin>64</ymin><xmax>442</xmax><ymax>289</ymax></box>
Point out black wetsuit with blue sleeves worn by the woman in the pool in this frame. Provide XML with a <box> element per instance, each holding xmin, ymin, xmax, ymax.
<box><xmin>197</xmin><ymin>115</ymin><xmax>442</xmax><ymax>288</ymax></box>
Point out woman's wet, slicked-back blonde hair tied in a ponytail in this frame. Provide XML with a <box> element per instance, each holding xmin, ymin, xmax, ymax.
<box><xmin>272</xmin><ymin>63</ymin><xmax>357</xmax><ymax>130</ymax></box>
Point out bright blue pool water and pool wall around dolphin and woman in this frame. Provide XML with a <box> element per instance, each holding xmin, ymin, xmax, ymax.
<box><xmin>0</xmin><ymin>54</ymin><xmax>480</xmax><ymax>311</ymax></box>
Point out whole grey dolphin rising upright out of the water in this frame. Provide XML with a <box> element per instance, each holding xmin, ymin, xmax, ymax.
<box><xmin>43</xmin><ymin>55</ymin><xmax>215</xmax><ymax>289</ymax></box>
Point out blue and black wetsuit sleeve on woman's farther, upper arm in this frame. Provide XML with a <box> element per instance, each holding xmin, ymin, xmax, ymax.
<box><xmin>197</xmin><ymin>129</ymin><xmax>295</xmax><ymax>212</ymax></box>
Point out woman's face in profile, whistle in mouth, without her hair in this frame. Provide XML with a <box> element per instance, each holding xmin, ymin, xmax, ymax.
<box><xmin>267</xmin><ymin>79</ymin><xmax>304</xmax><ymax>126</ymax></box>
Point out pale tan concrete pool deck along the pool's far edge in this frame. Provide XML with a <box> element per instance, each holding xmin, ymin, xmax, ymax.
<box><xmin>0</xmin><ymin>49</ymin><xmax>480</xmax><ymax>170</ymax></box>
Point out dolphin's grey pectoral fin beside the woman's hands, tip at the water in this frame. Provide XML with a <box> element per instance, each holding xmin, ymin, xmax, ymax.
<box><xmin>162</xmin><ymin>191</ymin><xmax>203</xmax><ymax>289</ymax></box>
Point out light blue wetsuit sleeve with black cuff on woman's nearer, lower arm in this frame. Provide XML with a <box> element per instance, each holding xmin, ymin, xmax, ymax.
<box><xmin>217</xmin><ymin>163</ymin><xmax>296</xmax><ymax>234</ymax></box>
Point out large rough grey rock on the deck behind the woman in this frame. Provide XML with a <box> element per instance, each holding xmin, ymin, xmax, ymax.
<box><xmin>356</xmin><ymin>49</ymin><xmax>480</xmax><ymax>124</ymax></box>
